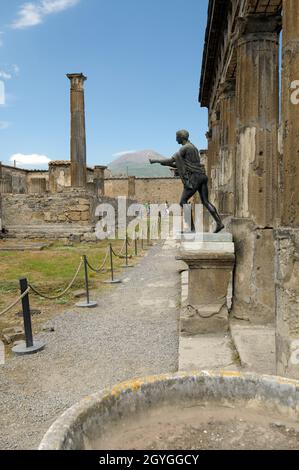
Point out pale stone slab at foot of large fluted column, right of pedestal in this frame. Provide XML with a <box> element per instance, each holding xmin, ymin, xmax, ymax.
<box><xmin>230</xmin><ymin>321</ymin><xmax>276</xmax><ymax>375</ymax></box>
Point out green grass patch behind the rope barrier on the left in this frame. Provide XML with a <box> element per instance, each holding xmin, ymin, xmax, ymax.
<box><xmin>0</xmin><ymin>240</ymin><xmax>144</xmax><ymax>307</ymax></box>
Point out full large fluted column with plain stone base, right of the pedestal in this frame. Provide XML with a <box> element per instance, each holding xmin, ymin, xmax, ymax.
<box><xmin>232</xmin><ymin>15</ymin><xmax>281</xmax><ymax>324</ymax></box>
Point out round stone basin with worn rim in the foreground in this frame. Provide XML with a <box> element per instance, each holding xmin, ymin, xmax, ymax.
<box><xmin>39</xmin><ymin>371</ymin><xmax>299</xmax><ymax>450</ymax></box>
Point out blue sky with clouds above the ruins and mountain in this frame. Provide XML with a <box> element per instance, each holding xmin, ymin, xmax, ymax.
<box><xmin>0</xmin><ymin>0</ymin><xmax>208</xmax><ymax>166</ymax></box>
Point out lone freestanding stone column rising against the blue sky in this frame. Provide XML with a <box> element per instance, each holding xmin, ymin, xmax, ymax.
<box><xmin>67</xmin><ymin>73</ymin><xmax>87</xmax><ymax>188</ymax></box>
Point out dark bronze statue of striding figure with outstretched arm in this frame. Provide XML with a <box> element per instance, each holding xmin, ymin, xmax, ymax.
<box><xmin>150</xmin><ymin>130</ymin><xmax>224</xmax><ymax>233</ymax></box>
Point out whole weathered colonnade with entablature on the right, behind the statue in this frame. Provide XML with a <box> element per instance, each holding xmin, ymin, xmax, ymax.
<box><xmin>199</xmin><ymin>0</ymin><xmax>299</xmax><ymax>378</ymax></box>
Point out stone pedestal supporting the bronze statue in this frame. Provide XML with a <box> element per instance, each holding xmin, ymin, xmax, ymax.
<box><xmin>179</xmin><ymin>233</ymin><xmax>235</xmax><ymax>336</ymax></box>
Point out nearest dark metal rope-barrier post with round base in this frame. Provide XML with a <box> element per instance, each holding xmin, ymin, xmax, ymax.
<box><xmin>12</xmin><ymin>278</ymin><xmax>45</xmax><ymax>356</ymax></box>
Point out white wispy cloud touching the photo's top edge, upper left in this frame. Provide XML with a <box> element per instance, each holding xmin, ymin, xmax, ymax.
<box><xmin>11</xmin><ymin>0</ymin><xmax>80</xmax><ymax>29</ymax></box>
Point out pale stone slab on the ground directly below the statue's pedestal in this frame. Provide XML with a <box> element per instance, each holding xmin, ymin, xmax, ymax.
<box><xmin>179</xmin><ymin>334</ymin><xmax>240</xmax><ymax>371</ymax></box>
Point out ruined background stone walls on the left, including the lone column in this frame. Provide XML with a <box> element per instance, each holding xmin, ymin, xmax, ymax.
<box><xmin>0</xmin><ymin>74</ymin><xmax>185</xmax><ymax>241</ymax></box>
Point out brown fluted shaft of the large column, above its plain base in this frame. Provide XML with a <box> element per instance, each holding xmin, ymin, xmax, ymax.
<box><xmin>236</xmin><ymin>15</ymin><xmax>281</xmax><ymax>227</ymax></box>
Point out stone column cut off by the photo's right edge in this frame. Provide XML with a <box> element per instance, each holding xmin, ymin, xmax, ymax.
<box><xmin>275</xmin><ymin>0</ymin><xmax>299</xmax><ymax>379</ymax></box>
